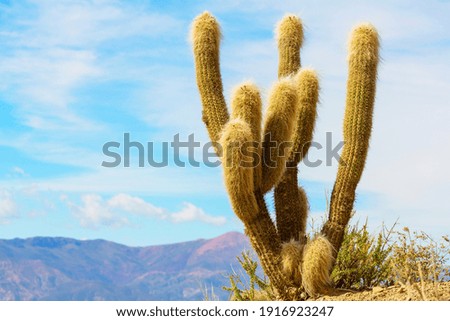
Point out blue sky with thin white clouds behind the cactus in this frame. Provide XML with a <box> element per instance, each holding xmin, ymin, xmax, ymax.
<box><xmin>0</xmin><ymin>0</ymin><xmax>450</xmax><ymax>245</ymax></box>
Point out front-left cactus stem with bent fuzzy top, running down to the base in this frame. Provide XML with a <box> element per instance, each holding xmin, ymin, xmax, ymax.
<box><xmin>220</xmin><ymin>119</ymin><xmax>289</xmax><ymax>298</ymax></box>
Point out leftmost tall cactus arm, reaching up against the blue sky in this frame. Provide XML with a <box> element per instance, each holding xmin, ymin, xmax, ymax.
<box><xmin>191</xmin><ymin>12</ymin><xmax>229</xmax><ymax>142</ymax></box>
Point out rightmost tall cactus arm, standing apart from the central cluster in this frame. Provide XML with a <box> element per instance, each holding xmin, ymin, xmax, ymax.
<box><xmin>322</xmin><ymin>24</ymin><xmax>379</xmax><ymax>255</ymax></box>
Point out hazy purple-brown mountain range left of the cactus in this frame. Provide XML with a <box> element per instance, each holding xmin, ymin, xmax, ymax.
<box><xmin>0</xmin><ymin>232</ymin><xmax>250</xmax><ymax>300</ymax></box>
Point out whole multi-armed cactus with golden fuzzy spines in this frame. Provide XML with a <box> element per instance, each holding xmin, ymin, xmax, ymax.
<box><xmin>191</xmin><ymin>12</ymin><xmax>379</xmax><ymax>300</ymax></box>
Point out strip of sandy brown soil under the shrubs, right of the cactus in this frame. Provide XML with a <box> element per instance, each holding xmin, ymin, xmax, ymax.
<box><xmin>310</xmin><ymin>282</ymin><xmax>450</xmax><ymax>301</ymax></box>
